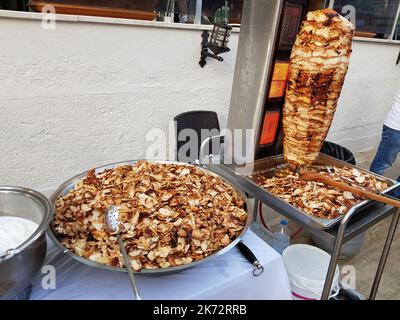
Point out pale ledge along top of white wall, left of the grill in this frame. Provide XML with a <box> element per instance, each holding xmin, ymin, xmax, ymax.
<box><xmin>0</xmin><ymin>10</ymin><xmax>240</xmax><ymax>32</ymax></box>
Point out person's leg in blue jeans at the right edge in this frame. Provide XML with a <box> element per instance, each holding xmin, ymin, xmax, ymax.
<box><xmin>370</xmin><ymin>126</ymin><xmax>400</xmax><ymax>178</ymax></box>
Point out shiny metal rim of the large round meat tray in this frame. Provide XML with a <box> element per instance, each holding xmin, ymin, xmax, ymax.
<box><xmin>47</xmin><ymin>160</ymin><xmax>252</xmax><ymax>275</ymax></box>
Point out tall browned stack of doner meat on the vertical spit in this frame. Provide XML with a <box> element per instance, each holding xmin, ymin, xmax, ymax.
<box><xmin>283</xmin><ymin>9</ymin><xmax>354</xmax><ymax>168</ymax></box>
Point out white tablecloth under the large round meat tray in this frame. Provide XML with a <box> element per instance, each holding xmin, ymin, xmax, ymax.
<box><xmin>31</xmin><ymin>231</ymin><xmax>291</xmax><ymax>300</ymax></box>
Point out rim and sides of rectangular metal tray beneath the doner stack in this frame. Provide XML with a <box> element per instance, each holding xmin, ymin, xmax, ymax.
<box><xmin>219</xmin><ymin>153</ymin><xmax>400</xmax><ymax>230</ymax></box>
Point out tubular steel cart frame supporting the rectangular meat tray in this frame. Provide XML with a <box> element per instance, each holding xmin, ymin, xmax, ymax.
<box><xmin>209</xmin><ymin>164</ymin><xmax>400</xmax><ymax>299</ymax></box>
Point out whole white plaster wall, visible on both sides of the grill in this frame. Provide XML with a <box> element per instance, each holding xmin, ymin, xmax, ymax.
<box><xmin>0</xmin><ymin>12</ymin><xmax>400</xmax><ymax>192</ymax></box>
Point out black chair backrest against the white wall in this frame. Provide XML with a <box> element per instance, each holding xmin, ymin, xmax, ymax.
<box><xmin>174</xmin><ymin>111</ymin><xmax>220</xmax><ymax>163</ymax></box>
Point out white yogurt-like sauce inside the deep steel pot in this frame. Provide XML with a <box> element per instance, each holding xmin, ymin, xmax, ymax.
<box><xmin>0</xmin><ymin>216</ymin><xmax>39</xmax><ymax>256</ymax></box>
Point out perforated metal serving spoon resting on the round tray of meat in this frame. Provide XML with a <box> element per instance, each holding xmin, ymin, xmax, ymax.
<box><xmin>105</xmin><ymin>206</ymin><xmax>142</xmax><ymax>300</ymax></box>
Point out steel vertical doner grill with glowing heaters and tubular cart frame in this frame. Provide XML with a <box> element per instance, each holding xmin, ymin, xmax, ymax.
<box><xmin>203</xmin><ymin>0</ymin><xmax>400</xmax><ymax>299</ymax></box>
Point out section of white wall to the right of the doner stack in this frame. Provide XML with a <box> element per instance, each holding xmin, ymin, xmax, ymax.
<box><xmin>328</xmin><ymin>41</ymin><xmax>400</xmax><ymax>153</ymax></box>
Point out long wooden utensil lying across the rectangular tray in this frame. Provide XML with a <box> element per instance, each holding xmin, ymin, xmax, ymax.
<box><xmin>300</xmin><ymin>171</ymin><xmax>400</xmax><ymax>208</ymax></box>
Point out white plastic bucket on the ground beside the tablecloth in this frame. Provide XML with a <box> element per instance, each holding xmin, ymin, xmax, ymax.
<box><xmin>282</xmin><ymin>244</ymin><xmax>340</xmax><ymax>300</ymax></box>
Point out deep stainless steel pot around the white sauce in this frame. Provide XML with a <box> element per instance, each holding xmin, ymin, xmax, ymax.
<box><xmin>0</xmin><ymin>187</ymin><xmax>54</xmax><ymax>300</ymax></box>
